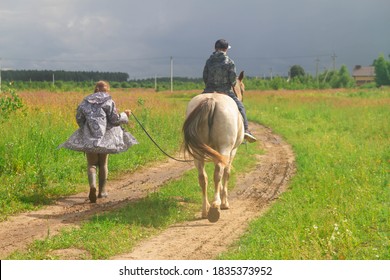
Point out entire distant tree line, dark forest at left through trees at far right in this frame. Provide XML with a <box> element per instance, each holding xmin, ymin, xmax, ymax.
<box><xmin>1</xmin><ymin>54</ymin><xmax>390</xmax><ymax>91</ymax></box>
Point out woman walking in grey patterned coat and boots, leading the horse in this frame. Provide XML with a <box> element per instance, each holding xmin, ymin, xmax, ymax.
<box><xmin>59</xmin><ymin>81</ymin><xmax>138</xmax><ymax>203</ymax></box>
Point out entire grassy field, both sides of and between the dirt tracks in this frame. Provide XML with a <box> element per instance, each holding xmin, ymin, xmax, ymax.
<box><xmin>0</xmin><ymin>89</ymin><xmax>390</xmax><ymax>260</ymax></box>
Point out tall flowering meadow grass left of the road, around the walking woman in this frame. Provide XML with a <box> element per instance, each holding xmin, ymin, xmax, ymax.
<box><xmin>0</xmin><ymin>92</ymin><xmax>185</xmax><ymax>221</ymax></box>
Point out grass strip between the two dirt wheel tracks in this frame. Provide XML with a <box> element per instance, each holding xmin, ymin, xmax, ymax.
<box><xmin>8</xmin><ymin>135</ymin><xmax>261</xmax><ymax>260</ymax></box>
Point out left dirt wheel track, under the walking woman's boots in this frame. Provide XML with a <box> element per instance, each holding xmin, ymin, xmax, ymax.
<box><xmin>0</xmin><ymin>160</ymin><xmax>193</xmax><ymax>259</ymax></box>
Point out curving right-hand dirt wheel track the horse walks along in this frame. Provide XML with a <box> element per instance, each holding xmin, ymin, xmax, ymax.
<box><xmin>113</xmin><ymin>124</ymin><xmax>295</xmax><ymax>260</ymax></box>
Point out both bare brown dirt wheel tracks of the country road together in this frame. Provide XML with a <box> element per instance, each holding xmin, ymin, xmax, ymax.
<box><xmin>0</xmin><ymin>123</ymin><xmax>295</xmax><ymax>260</ymax></box>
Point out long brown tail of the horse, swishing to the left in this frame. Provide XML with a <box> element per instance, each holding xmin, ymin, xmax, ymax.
<box><xmin>183</xmin><ymin>98</ymin><xmax>227</xmax><ymax>165</ymax></box>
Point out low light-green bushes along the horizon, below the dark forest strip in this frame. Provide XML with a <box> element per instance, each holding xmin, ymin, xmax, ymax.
<box><xmin>3</xmin><ymin>66</ymin><xmax>362</xmax><ymax>91</ymax></box>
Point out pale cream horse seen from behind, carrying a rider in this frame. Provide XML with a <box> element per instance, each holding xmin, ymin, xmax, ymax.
<box><xmin>183</xmin><ymin>71</ymin><xmax>245</xmax><ymax>222</ymax></box>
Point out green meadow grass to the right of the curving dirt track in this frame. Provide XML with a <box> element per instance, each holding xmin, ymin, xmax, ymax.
<box><xmin>220</xmin><ymin>90</ymin><xmax>390</xmax><ymax>260</ymax></box>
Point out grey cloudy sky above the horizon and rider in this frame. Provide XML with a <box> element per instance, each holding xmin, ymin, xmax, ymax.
<box><xmin>0</xmin><ymin>0</ymin><xmax>390</xmax><ymax>78</ymax></box>
